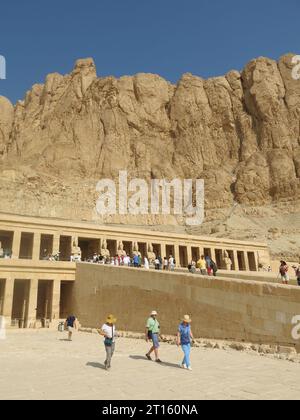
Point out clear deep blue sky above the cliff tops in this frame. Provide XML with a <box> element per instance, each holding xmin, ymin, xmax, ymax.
<box><xmin>0</xmin><ymin>0</ymin><xmax>300</xmax><ymax>102</ymax></box>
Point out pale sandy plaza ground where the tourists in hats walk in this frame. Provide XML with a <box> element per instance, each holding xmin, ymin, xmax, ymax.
<box><xmin>0</xmin><ymin>330</ymin><xmax>300</xmax><ymax>400</ymax></box>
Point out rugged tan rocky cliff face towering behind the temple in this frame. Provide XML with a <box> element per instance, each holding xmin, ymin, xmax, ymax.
<box><xmin>0</xmin><ymin>55</ymin><xmax>300</xmax><ymax>254</ymax></box>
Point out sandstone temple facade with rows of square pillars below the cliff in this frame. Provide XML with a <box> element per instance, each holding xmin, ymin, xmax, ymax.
<box><xmin>0</xmin><ymin>213</ymin><xmax>270</xmax><ymax>327</ymax></box>
